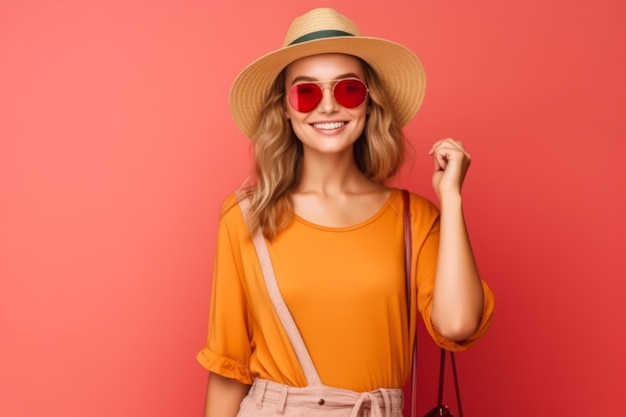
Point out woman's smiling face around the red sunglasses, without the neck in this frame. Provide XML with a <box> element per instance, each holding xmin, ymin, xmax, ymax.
<box><xmin>284</xmin><ymin>54</ymin><xmax>368</xmax><ymax>155</ymax></box>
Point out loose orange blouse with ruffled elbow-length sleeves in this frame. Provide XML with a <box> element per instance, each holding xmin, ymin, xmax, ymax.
<box><xmin>197</xmin><ymin>189</ymin><xmax>494</xmax><ymax>392</ymax></box>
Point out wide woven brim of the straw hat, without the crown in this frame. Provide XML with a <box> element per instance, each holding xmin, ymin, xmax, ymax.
<box><xmin>229</xmin><ymin>36</ymin><xmax>426</xmax><ymax>138</ymax></box>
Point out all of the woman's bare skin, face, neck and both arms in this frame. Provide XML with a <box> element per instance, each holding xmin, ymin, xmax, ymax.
<box><xmin>205</xmin><ymin>54</ymin><xmax>483</xmax><ymax>417</ymax></box>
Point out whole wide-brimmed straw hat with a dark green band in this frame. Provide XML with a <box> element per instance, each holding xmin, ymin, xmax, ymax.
<box><xmin>230</xmin><ymin>8</ymin><xmax>426</xmax><ymax>138</ymax></box>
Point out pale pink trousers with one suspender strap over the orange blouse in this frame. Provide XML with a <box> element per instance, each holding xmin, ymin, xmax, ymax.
<box><xmin>237</xmin><ymin>198</ymin><xmax>404</xmax><ymax>417</ymax></box>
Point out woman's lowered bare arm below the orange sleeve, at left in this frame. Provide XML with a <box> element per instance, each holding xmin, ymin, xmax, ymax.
<box><xmin>204</xmin><ymin>373</ymin><xmax>250</xmax><ymax>417</ymax></box>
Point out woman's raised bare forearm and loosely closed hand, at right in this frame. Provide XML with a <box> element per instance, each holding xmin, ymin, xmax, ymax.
<box><xmin>429</xmin><ymin>139</ymin><xmax>484</xmax><ymax>341</ymax></box>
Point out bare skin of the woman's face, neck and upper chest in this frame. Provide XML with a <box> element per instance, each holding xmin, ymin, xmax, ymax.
<box><xmin>285</xmin><ymin>54</ymin><xmax>390</xmax><ymax>227</ymax></box>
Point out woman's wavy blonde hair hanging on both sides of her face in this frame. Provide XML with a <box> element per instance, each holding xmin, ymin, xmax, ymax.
<box><xmin>242</xmin><ymin>58</ymin><xmax>406</xmax><ymax>240</ymax></box>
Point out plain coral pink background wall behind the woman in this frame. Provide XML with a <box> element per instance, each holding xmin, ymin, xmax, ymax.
<box><xmin>0</xmin><ymin>0</ymin><xmax>626</xmax><ymax>417</ymax></box>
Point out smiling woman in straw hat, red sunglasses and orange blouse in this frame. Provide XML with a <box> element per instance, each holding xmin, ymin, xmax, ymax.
<box><xmin>198</xmin><ymin>9</ymin><xmax>493</xmax><ymax>417</ymax></box>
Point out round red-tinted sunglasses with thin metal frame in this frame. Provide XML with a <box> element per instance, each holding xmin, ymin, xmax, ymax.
<box><xmin>289</xmin><ymin>78</ymin><xmax>368</xmax><ymax>113</ymax></box>
